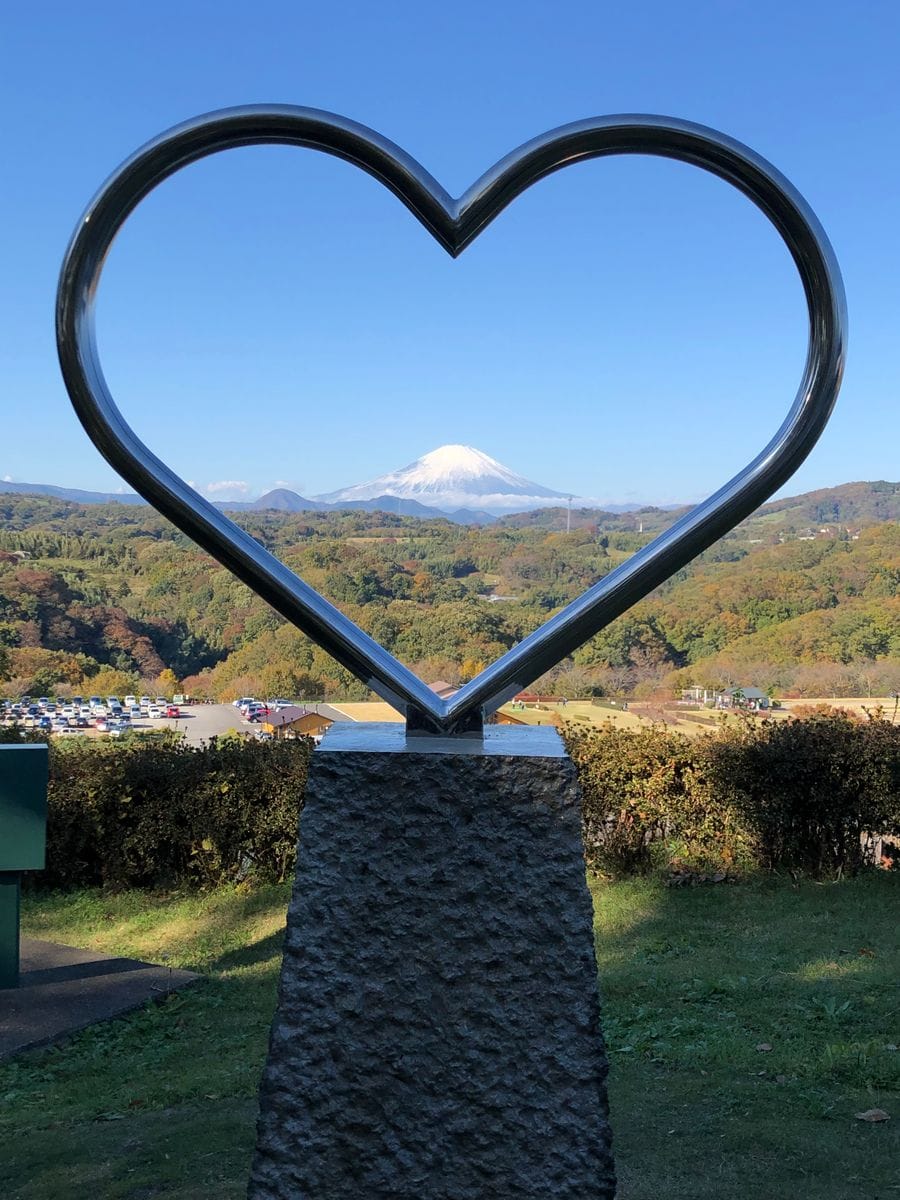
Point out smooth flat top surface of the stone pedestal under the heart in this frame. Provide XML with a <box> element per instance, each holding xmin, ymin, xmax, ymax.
<box><xmin>316</xmin><ymin>721</ymin><xmax>565</xmax><ymax>758</ymax></box>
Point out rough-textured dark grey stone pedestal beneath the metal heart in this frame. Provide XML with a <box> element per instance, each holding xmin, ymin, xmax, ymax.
<box><xmin>248</xmin><ymin>727</ymin><xmax>614</xmax><ymax>1200</ymax></box>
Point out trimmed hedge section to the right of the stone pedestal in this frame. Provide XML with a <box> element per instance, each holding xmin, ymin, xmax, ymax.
<box><xmin>565</xmin><ymin>712</ymin><xmax>900</xmax><ymax>876</ymax></box>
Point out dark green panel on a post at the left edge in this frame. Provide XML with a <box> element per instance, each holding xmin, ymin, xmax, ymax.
<box><xmin>0</xmin><ymin>744</ymin><xmax>47</xmax><ymax>872</ymax></box>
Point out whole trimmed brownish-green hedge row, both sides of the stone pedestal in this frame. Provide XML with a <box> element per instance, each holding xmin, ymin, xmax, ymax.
<box><xmin>8</xmin><ymin>713</ymin><xmax>900</xmax><ymax>887</ymax></box>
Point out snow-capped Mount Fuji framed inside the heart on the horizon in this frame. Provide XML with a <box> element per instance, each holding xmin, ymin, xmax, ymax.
<box><xmin>316</xmin><ymin>445</ymin><xmax>570</xmax><ymax>516</ymax></box>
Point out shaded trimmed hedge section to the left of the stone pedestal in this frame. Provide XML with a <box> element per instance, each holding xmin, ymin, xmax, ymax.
<box><xmin>35</xmin><ymin>739</ymin><xmax>310</xmax><ymax>887</ymax></box>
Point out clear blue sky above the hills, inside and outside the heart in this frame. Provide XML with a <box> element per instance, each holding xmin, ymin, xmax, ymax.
<box><xmin>0</xmin><ymin>0</ymin><xmax>900</xmax><ymax>503</ymax></box>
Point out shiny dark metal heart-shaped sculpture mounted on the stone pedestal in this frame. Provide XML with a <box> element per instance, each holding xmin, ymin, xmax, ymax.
<box><xmin>56</xmin><ymin>104</ymin><xmax>846</xmax><ymax>733</ymax></box>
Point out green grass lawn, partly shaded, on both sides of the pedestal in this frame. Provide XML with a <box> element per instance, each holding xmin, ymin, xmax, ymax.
<box><xmin>0</xmin><ymin>874</ymin><xmax>900</xmax><ymax>1200</ymax></box>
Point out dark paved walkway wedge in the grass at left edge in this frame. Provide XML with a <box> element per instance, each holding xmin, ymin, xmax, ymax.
<box><xmin>0</xmin><ymin>937</ymin><xmax>198</xmax><ymax>1061</ymax></box>
